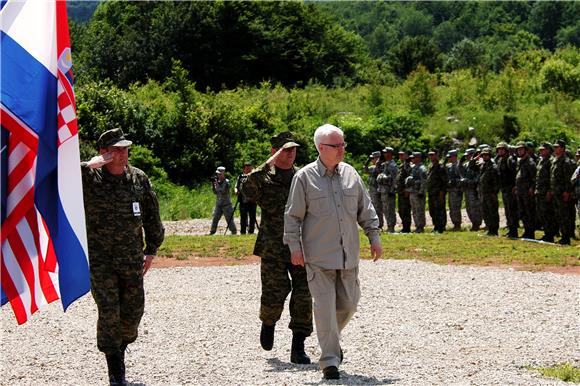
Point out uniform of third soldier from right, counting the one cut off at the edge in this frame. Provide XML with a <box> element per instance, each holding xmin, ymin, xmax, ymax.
<box><xmin>535</xmin><ymin>151</ymin><xmax>556</xmax><ymax>242</ymax></box>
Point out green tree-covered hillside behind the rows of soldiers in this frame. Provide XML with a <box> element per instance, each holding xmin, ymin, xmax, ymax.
<box><xmin>71</xmin><ymin>1</ymin><xmax>580</xmax><ymax>186</ymax></box>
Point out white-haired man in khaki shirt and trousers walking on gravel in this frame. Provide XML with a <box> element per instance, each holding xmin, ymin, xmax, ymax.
<box><xmin>284</xmin><ymin>124</ymin><xmax>382</xmax><ymax>379</ymax></box>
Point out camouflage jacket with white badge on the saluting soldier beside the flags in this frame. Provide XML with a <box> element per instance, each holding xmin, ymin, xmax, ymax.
<box><xmin>81</xmin><ymin>163</ymin><xmax>164</xmax><ymax>264</ymax></box>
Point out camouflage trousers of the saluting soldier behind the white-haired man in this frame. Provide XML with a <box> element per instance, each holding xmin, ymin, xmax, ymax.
<box><xmin>260</xmin><ymin>258</ymin><xmax>312</xmax><ymax>336</ymax></box>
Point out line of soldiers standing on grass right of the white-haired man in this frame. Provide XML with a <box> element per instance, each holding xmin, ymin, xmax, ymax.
<box><xmin>365</xmin><ymin>140</ymin><xmax>580</xmax><ymax>245</ymax></box>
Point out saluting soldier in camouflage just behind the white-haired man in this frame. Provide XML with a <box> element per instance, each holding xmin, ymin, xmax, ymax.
<box><xmin>241</xmin><ymin>132</ymin><xmax>312</xmax><ymax>364</ymax></box>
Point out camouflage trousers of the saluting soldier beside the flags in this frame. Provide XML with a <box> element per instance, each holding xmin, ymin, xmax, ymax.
<box><xmin>90</xmin><ymin>256</ymin><xmax>145</xmax><ymax>355</ymax></box>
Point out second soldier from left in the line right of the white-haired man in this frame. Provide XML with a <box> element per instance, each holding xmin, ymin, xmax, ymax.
<box><xmin>377</xmin><ymin>146</ymin><xmax>398</xmax><ymax>233</ymax></box>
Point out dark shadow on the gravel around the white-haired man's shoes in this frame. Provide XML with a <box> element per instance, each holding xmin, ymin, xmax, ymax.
<box><xmin>266</xmin><ymin>358</ymin><xmax>398</xmax><ymax>385</ymax></box>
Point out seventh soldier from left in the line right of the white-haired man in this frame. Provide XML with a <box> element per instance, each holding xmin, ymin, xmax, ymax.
<box><xmin>461</xmin><ymin>148</ymin><xmax>482</xmax><ymax>232</ymax></box>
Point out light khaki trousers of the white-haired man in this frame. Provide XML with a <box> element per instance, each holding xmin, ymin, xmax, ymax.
<box><xmin>306</xmin><ymin>264</ymin><xmax>360</xmax><ymax>369</ymax></box>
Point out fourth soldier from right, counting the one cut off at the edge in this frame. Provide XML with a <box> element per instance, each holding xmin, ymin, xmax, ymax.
<box><xmin>514</xmin><ymin>141</ymin><xmax>536</xmax><ymax>239</ymax></box>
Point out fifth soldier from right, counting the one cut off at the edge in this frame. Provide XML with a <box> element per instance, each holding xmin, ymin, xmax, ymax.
<box><xmin>496</xmin><ymin>142</ymin><xmax>519</xmax><ymax>238</ymax></box>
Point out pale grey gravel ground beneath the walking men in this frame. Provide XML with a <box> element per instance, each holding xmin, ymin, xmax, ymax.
<box><xmin>0</xmin><ymin>260</ymin><xmax>580</xmax><ymax>386</ymax></box>
